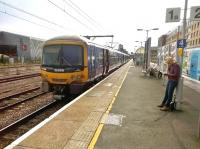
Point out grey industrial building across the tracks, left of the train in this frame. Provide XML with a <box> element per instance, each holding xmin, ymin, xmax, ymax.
<box><xmin>0</xmin><ymin>31</ymin><xmax>44</xmax><ymax>60</ymax></box>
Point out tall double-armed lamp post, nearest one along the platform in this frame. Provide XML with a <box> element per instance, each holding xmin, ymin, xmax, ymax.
<box><xmin>137</xmin><ymin>28</ymin><xmax>159</xmax><ymax>71</ymax></box>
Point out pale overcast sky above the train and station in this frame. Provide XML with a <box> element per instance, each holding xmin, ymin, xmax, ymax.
<box><xmin>0</xmin><ymin>0</ymin><xmax>200</xmax><ymax>52</ymax></box>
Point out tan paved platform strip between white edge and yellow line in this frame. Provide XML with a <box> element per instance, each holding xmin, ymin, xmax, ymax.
<box><xmin>7</xmin><ymin>62</ymin><xmax>131</xmax><ymax>149</ymax></box>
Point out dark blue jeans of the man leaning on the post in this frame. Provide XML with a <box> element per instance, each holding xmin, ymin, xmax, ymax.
<box><xmin>162</xmin><ymin>80</ymin><xmax>178</xmax><ymax>107</ymax></box>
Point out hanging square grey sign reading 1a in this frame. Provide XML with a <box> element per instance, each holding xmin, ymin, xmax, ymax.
<box><xmin>165</xmin><ymin>7</ymin><xmax>181</xmax><ymax>23</ymax></box>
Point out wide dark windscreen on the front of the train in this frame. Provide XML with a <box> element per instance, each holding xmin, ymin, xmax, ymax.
<box><xmin>42</xmin><ymin>45</ymin><xmax>83</xmax><ymax>67</ymax></box>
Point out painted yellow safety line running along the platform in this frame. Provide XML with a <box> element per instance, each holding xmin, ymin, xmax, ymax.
<box><xmin>88</xmin><ymin>66</ymin><xmax>130</xmax><ymax>149</ymax></box>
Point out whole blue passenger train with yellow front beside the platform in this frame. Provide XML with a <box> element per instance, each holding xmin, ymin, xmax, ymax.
<box><xmin>41</xmin><ymin>36</ymin><xmax>129</xmax><ymax>95</ymax></box>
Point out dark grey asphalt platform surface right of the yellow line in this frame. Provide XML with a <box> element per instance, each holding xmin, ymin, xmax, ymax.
<box><xmin>94</xmin><ymin>63</ymin><xmax>200</xmax><ymax>149</ymax></box>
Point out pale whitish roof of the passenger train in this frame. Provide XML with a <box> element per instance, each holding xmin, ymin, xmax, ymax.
<box><xmin>46</xmin><ymin>35</ymin><xmax>128</xmax><ymax>56</ymax></box>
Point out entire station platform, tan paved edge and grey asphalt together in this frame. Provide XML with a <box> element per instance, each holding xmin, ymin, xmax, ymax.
<box><xmin>7</xmin><ymin>62</ymin><xmax>200</xmax><ymax>149</ymax></box>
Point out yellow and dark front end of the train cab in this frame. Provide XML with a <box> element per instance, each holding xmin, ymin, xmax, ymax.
<box><xmin>41</xmin><ymin>40</ymin><xmax>88</xmax><ymax>94</ymax></box>
